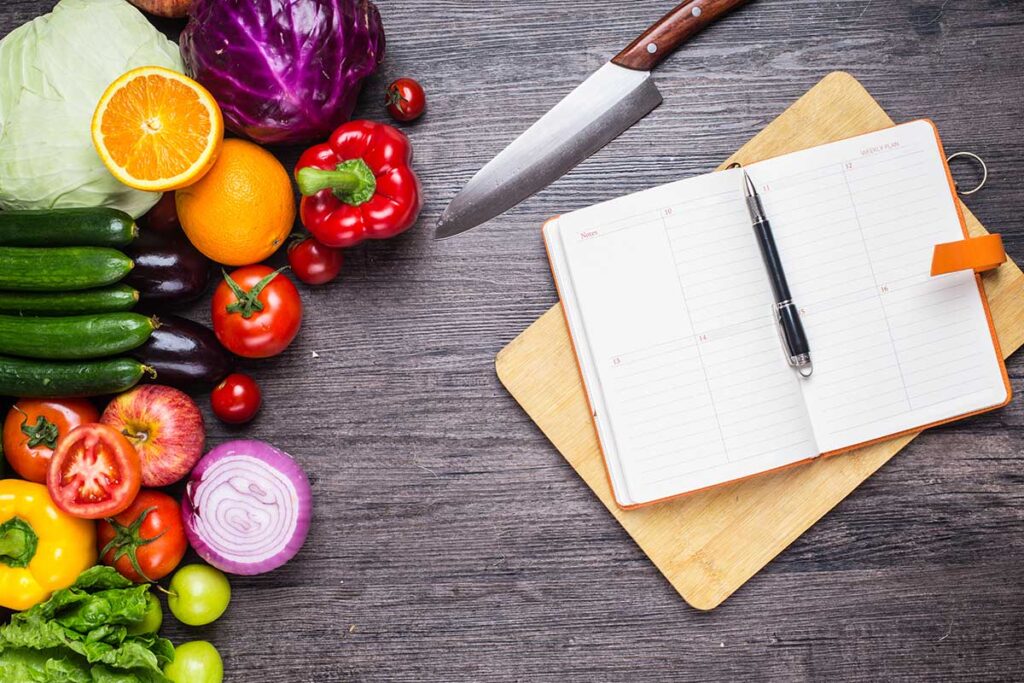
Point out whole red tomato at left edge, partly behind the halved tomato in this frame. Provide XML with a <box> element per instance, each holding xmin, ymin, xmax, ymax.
<box><xmin>3</xmin><ymin>398</ymin><xmax>99</xmax><ymax>483</ymax></box>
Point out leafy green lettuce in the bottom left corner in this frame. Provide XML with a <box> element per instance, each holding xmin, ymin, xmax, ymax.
<box><xmin>0</xmin><ymin>566</ymin><xmax>174</xmax><ymax>683</ymax></box>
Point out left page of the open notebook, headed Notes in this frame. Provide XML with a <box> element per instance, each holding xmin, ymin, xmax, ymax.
<box><xmin>558</xmin><ymin>171</ymin><xmax>818</xmax><ymax>504</ymax></box>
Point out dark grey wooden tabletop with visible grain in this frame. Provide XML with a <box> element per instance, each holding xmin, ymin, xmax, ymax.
<box><xmin>0</xmin><ymin>0</ymin><xmax>1024</xmax><ymax>683</ymax></box>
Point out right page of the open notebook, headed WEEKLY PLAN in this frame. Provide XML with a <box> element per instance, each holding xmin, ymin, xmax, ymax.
<box><xmin>748</xmin><ymin>121</ymin><xmax>1007</xmax><ymax>453</ymax></box>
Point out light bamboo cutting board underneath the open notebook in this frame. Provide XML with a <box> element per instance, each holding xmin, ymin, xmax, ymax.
<box><xmin>497</xmin><ymin>72</ymin><xmax>1024</xmax><ymax>609</ymax></box>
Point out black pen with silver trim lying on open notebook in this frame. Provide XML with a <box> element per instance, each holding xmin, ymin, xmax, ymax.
<box><xmin>743</xmin><ymin>171</ymin><xmax>814</xmax><ymax>377</ymax></box>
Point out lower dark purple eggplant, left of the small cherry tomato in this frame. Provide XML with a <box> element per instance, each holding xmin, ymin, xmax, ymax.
<box><xmin>131</xmin><ymin>315</ymin><xmax>234</xmax><ymax>390</ymax></box>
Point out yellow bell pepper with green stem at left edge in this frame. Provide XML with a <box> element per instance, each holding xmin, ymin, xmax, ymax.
<box><xmin>0</xmin><ymin>479</ymin><xmax>96</xmax><ymax>611</ymax></box>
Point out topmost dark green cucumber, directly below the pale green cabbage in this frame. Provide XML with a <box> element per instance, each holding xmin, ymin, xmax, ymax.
<box><xmin>0</xmin><ymin>207</ymin><xmax>138</xmax><ymax>247</ymax></box>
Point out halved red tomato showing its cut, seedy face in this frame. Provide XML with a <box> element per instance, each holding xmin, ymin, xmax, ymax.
<box><xmin>46</xmin><ymin>423</ymin><xmax>142</xmax><ymax>519</ymax></box>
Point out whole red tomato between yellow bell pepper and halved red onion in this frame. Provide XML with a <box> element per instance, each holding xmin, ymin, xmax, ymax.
<box><xmin>96</xmin><ymin>488</ymin><xmax>188</xmax><ymax>584</ymax></box>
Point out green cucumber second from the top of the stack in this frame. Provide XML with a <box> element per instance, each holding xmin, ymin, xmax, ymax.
<box><xmin>0</xmin><ymin>247</ymin><xmax>135</xmax><ymax>292</ymax></box>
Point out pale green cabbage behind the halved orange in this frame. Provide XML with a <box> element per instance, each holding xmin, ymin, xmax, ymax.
<box><xmin>0</xmin><ymin>0</ymin><xmax>183</xmax><ymax>216</ymax></box>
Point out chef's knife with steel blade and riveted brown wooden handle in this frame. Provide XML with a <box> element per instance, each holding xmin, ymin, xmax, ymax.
<box><xmin>434</xmin><ymin>0</ymin><xmax>749</xmax><ymax>240</ymax></box>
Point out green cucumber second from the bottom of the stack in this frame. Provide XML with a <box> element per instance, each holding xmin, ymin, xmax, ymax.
<box><xmin>0</xmin><ymin>313</ymin><xmax>157</xmax><ymax>360</ymax></box>
